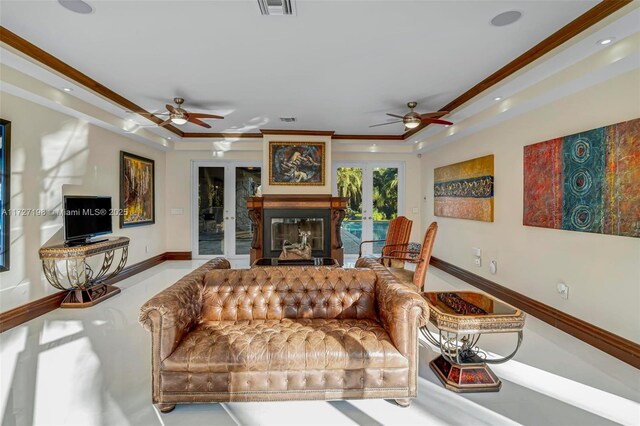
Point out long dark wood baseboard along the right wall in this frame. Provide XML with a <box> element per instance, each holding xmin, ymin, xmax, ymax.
<box><xmin>430</xmin><ymin>257</ymin><xmax>640</xmax><ymax>369</ymax></box>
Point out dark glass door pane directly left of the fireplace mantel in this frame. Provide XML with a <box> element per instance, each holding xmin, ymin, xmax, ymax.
<box><xmin>235</xmin><ymin>167</ymin><xmax>261</xmax><ymax>255</ymax></box>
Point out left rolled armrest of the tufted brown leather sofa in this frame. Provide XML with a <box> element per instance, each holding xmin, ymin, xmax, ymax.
<box><xmin>139</xmin><ymin>258</ymin><xmax>231</xmax><ymax>362</ymax></box>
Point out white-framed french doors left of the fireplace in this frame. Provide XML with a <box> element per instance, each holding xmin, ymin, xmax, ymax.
<box><xmin>191</xmin><ymin>161</ymin><xmax>261</xmax><ymax>259</ymax></box>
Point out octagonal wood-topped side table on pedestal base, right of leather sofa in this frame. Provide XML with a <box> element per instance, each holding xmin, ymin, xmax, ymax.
<box><xmin>420</xmin><ymin>291</ymin><xmax>525</xmax><ymax>392</ymax></box>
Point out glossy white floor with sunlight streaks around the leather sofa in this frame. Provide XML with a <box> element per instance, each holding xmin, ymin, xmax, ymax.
<box><xmin>0</xmin><ymin>261</ymin><xmax>640</xmax><ymax>426</ymax></box>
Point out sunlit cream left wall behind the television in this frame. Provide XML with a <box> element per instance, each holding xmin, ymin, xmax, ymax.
<box><xmin>0</xmin><ymin>92</ymin><xmax>166</xmax><ymax>311</ymax></box>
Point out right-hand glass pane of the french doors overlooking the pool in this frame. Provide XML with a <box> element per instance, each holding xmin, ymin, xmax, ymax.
<box><xmin>372</xmin><ymin>167</ymin><xmax>399</xmax><ymax>254</ymax></box>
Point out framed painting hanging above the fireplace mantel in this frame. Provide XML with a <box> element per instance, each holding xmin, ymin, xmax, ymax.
<box><xmin>269</xmin><ymin>142</ymin><xmax>325</xmax><ymax>186</ymax></box>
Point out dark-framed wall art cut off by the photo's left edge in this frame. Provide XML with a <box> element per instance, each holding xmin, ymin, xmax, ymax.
<box><xmin>0</xmin><ymin>118</ymin><xmax>11</xmax><ymax>272</ymax></box>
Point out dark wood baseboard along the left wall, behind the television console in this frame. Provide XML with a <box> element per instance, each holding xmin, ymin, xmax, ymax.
<box><xmin>0</xmin><ymin>251</ymin><xmax>191</xmax><ymax>333</ymax></box>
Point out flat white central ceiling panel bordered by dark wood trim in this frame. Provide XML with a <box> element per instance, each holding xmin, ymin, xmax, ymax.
<box><xmin>0</xmin><ymin>0</ymin><xmax>598</xmax><ymax>135</ymax></box>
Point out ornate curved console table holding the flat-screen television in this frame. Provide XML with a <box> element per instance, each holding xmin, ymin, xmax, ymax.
<box><xmin>39</xmin><ymin>237</ymin><xmax>129</xmax><ymax>308</ymax></box>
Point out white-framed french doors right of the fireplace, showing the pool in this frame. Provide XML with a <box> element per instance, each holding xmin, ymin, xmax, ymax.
<box><xmin>333</xmin><ymin>162</ymin><xmax>404</xmax><ymax>262</ymax></box>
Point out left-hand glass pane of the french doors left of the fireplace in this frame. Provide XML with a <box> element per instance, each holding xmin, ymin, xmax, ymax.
<box><xmin>198</xmin><ymin>167</ymin><xmax>225</xmax><ymax>255</ymax></box>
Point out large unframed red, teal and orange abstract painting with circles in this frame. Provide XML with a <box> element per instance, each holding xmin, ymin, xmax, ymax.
<box><xmin>523</xmin><ymin>119</ymin><xmax>640</xmax><ymax>237</ymax></box>
